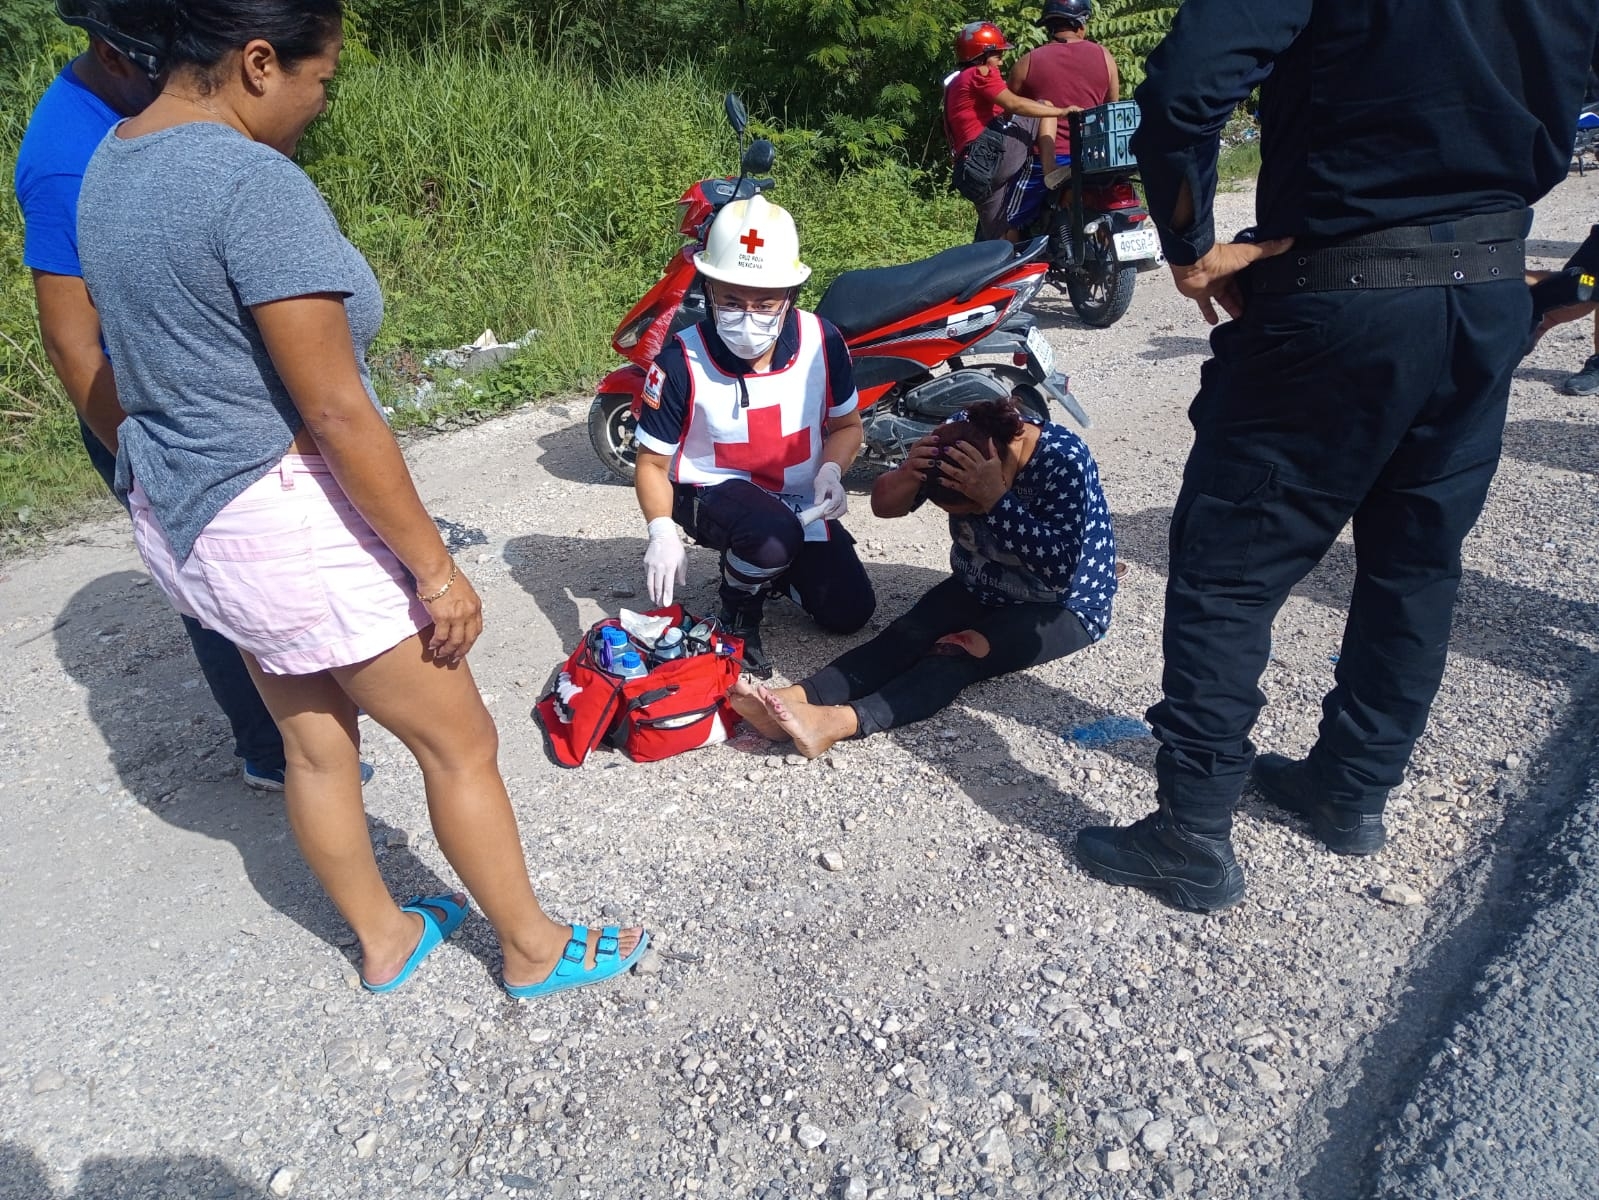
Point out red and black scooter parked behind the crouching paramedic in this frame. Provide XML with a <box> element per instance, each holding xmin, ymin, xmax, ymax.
<box><xmin>588</xmin><ymin>96</ymin><xmax>1089</xmax><ymax>482</ymax></box>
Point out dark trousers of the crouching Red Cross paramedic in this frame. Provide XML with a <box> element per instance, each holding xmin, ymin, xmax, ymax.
<box><xmin>672</xmin><ymin>480</ymin><xmax>878</xmax><ymax>634</ymax></box>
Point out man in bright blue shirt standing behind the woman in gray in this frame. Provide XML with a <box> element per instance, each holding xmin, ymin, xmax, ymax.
<box><xmin>14</xmin><ymin>0</ymin><xmax>300</xmax><ymax>790</ymax></box>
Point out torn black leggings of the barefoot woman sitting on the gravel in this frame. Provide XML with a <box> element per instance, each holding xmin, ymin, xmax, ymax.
<box><xmin>800</xmin><ymin>579</ymin><xmax>1094</xmax><ymax>738</ymax></box>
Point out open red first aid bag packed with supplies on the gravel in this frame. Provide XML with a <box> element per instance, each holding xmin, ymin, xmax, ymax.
<box><xmin>534</xmin><ymin>605</ymin><xmax>744</xmax><ymax>766</ymax></box>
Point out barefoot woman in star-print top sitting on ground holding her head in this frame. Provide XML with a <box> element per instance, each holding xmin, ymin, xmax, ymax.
<box><xmin>732</xmin><ymin>398</ymin><xmax>1118</xmax><ymax>758</ymax></box>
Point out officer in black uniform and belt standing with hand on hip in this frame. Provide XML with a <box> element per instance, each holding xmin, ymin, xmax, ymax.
<box><xmin>1076</xmin><ymin>0</ymin><xmax>1599</xmax><ymax>912</ymax></box>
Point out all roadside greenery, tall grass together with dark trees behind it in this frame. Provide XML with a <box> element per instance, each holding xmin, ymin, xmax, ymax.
<box><xmin>0</xmin><ymin>0</ymin><xmax>1228</xmax><ymax>539</ymax></box>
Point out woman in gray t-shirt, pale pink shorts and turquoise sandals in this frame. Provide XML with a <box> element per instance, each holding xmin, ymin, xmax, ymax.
<box><xmin>78</xmin><ymin>0</ymin><xmax>648</xmax><ymax>997</ymax></box>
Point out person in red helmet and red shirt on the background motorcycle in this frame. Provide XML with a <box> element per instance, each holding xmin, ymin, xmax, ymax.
<box><xmin>1006</xmin><ymin>0</ymin><xmax>1121</xmax><ymax>229</ymax></box>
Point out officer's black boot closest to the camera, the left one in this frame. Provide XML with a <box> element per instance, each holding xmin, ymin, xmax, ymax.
<box><xmin>1078</xmin><ymin>808</ymin><xmax>1244</xmax><ymax>912</ymax></box>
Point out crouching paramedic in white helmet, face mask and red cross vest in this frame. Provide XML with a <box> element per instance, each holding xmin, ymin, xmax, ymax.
<box><xmin>633</xmin><ymin>195</ymin><xmax>876</xmax><ymax>678</ymax></box>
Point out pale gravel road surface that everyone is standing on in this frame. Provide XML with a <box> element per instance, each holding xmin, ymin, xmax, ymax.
<box><xmin>0</xmin><ymin>176</ymin><xmax>1599</xmax><ymax>1200</ymax></box>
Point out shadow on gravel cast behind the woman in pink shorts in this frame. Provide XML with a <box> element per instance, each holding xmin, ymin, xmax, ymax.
<box><xmin>51</xmin><ymin>571</ymin><xmax>482</xmax><ymax>968</ymax></box>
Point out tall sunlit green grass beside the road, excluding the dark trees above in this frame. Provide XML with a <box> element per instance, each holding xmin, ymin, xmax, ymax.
<box><xmin>0</xmin><ymin>50</ymin><xmax>971</xmax><ymax>531</ymax></box>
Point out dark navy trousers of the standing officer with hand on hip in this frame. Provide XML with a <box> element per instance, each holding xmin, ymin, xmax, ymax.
<box><xmin>1148</xmin><ymin>281</ymin><xmax>1530</xmax><ymax>835</ymax></box>
